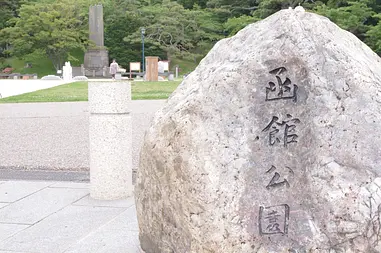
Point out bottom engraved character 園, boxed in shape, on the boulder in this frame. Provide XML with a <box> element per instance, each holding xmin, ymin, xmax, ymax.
<box><xmin>259</xmin><ymin>204</ymin><xmax>290</xmax><ymax>235</ymax></box>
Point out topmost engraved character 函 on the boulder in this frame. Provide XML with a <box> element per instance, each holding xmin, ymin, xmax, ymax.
<box><xmin>266</xmin><ymin>67</ymin><xmax>298</xmax><ymax>102</ymax></box>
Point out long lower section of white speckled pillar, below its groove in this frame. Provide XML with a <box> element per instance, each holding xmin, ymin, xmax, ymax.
<box><xmin>89</xmin><ymin>114</ymin><xmax>133</xmax><ymax>200</ymax></box>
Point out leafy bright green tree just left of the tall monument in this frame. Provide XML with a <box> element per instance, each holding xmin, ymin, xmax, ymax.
<box><xmin>0</xmin><ymin>0</ymin><xmax>88</xmax><ymax>70</ymax></box>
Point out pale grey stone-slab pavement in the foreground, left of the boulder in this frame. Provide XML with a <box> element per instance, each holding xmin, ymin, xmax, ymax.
<box><xmin>0</xmin><ymin>181</ymin><xmax>140</xmax><ymax>253</ymax></box>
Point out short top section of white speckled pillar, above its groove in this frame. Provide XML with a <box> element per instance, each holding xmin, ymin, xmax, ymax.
<box><xmin>88</xmin><ymin>80</ymin><xmax>131</xmax><ymax>114</ymax></box>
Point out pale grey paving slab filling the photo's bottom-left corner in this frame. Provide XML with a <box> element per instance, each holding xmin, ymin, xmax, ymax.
<box><xmin>0</xmin><ymin>206</ymin><xmax>125</xmax><ymax>253</ymax></box>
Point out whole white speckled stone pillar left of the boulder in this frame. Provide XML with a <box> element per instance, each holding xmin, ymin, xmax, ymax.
<box><xmin>89</xmin><ymin>81</ymin><xmax>133</xmax><ymax>200</ymax></box>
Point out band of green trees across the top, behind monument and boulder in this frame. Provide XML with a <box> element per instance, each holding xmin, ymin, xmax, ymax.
<box><xmin>0</xmin><ymin>0</ymin><xmax>381</xmax><ymax>76</ymax></box>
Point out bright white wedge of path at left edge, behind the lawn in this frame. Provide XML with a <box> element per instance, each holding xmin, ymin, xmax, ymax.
<box><xmin>0</xmin><ymin>79</ymin><xmax>73</xmax><ymax>98</ymax></box>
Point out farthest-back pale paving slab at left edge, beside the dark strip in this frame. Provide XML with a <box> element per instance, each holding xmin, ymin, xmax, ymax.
<box><xmin>0</xmin><ymin>181</ymin><xmax>52</xmax><ymax>202</ymax></box>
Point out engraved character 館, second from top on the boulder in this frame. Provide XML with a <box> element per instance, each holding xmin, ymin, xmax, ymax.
<box><xmin>262</xmin><ymin>114</ymin><xmax>300</xmax><ymax>147</ymax></box>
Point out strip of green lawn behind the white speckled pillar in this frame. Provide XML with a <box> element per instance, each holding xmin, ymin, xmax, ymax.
<box><xmin>0</xmin><ymin>81</ymin><xmax>181</xmax><ymax>103</ymax></box>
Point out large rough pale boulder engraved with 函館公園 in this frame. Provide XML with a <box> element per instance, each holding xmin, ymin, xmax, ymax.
<box><xmin>135</xmin><ymin>7</ymin><xmax>381</xmax><ymax>253</ymax></box>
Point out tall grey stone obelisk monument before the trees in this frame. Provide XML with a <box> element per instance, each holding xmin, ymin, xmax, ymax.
<box><xmin>84</xmin><ymin>5</ymin><xmax>109</xmax><ymax>76</ymax></box>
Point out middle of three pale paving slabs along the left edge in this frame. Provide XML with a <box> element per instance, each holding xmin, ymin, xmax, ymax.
<box><xmin>0</xmin><ymin>188</ymin><xmax>88</xmax><ymax>224</ymax></box>
